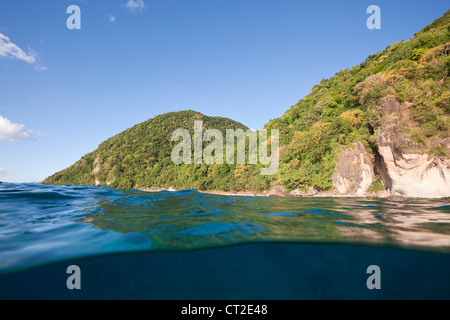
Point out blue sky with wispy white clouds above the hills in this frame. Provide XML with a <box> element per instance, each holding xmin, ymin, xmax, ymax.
<box><xmin>0</xmin><ymin>0</ymin><xmax>449</xmax><ymax>182</ymax></box>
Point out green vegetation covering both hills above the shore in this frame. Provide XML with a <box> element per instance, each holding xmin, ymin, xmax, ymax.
<box><xmin>44</xmin><ymin>11</ymin><xmax>450</xmax><ymax>191</ymax></box>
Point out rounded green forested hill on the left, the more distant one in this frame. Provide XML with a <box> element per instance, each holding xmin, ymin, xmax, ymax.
<box><xmin>43</xmin><ymin>111</ymin><xmax>268</xmax><ymax>191</ymax></box>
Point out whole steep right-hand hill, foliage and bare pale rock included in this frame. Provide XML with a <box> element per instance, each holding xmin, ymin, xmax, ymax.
<box><xmin>266</xmin><ymin>11</ymin><xmax>450</xmax><ymax>198</ymax></box>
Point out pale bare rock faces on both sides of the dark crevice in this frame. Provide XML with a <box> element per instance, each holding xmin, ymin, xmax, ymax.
<box><xmin>333</xmin><ymin>140</ymin><xmax>450</xmax><ymax>198</ymax></box>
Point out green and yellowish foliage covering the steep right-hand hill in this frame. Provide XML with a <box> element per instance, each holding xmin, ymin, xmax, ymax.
<box><xmin>265</xmin><ymin>10</ymin><xmax>450</xmax><ymax>190</ymax></box>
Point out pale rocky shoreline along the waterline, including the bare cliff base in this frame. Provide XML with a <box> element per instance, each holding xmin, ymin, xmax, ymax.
<box><xmin>139</xmin><ymin>136</ymin><xmax>450</xmax><ymax>199</ymax></box>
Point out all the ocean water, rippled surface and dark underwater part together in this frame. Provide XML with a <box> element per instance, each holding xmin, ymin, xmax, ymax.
<box><xmin>0</xmin><ymin>183</ymin><xmax>450</xmax><ymax>299</ymax></box>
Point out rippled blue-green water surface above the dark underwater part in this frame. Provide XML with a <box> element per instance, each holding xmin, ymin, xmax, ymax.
<box><xmin>0</xmin><ymin>183</ymin><xmax>450</xmax><ymax>273</ymax></box>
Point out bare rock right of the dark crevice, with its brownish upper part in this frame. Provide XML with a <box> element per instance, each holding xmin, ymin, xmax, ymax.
<box><xmin>374</xmin><ymin>96</ymin><xmax>450</xmax><ymax>198</ymax></box>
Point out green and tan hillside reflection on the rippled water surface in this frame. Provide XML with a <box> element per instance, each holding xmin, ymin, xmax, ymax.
<box><xmin>83</xmin><ymin>190</ymin><xmax>450</xmax><ymax>251</ymax></box>
